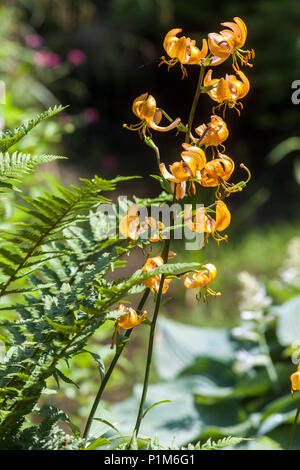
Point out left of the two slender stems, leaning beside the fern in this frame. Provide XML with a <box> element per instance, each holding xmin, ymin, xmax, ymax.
<box><xmin>83</xmin><ymin>288</ymin><xmax>150</xmax><ymax>438</ymax></box>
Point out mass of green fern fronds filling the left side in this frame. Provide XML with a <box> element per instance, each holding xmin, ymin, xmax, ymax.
<box><xmin>0</xmin><ymin>104</ymin><xmax>207</xmax><ymax>449</ymax></box>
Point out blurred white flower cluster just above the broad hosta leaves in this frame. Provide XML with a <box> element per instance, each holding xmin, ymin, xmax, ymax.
<box><xmin>238</xmin><ymin>271</ymin><xmax>272</xmax><ymax>321</ymax></box>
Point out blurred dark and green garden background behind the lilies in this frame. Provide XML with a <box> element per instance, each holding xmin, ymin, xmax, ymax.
<box><xmin>0</xmin><ymin>0</ymin><xmax>300</xmax><ymax>448</ymax></box>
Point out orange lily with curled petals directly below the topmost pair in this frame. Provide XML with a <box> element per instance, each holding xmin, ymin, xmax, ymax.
<box><xmin>203</xmin><ymin>69</ymin><xmax>250</xmax><ymax>116</ymax></box>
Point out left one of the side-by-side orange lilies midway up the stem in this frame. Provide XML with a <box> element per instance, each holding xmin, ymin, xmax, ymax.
<box><xmin>160</xmin><ymin>143</ymin><xmax>206</xmax><ymax>200</ymax></box>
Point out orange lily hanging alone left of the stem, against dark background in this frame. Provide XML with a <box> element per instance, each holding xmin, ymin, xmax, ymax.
<box><xmin>123</xmin><ymin>93</ymin><xmax>180</xmax><ymax>138</ymax></box>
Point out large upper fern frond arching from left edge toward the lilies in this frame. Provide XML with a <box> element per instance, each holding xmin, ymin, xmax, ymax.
<box><xmin>0</xmin><ymin>176</ymin><xmax>129</xmax><ymax>297</ymax></box>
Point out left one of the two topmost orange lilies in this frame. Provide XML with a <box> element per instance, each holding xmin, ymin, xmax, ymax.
<box><xmin>159</xmin><ymin>28</ymin><xmax>208</xmax><ymax>78</ymax></box>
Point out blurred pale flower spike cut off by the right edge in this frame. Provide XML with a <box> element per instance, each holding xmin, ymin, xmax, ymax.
<box><xmin>279</xmin><ymin>237</ymin><xmax>300</xmax><ymax>288</ymax></box>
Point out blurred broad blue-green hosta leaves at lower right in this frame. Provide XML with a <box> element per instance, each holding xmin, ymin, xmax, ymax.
<box><xmin>112</xmin><ymin>274</ymin><xmax>300</xmax><ymax>450</ymax></box>
